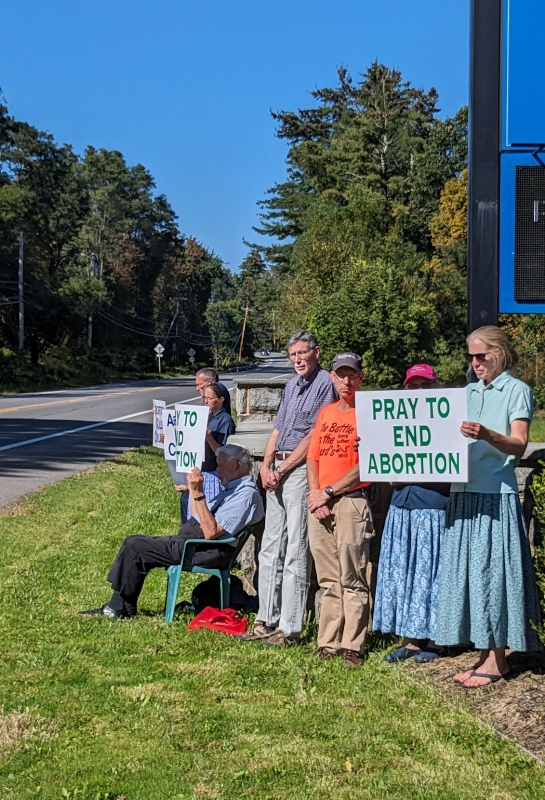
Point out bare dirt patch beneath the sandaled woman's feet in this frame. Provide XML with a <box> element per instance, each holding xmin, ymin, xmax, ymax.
<box><xmin>404</xmin><ymin>652</ymin><xmax>545</xmax><ymax>760</ymax></box>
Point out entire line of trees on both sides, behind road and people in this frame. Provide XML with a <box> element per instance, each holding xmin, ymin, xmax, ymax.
<box><xmin>0</xmin><ymin>61</ymin><xmax>545</xmax><ymax>392</ymax></box>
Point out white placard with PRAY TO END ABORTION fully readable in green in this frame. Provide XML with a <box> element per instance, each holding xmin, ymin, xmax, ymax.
<box><xmin>356</xmin><ymin>389</ymin><xmax>468</xmax><ymax>483</ymax></box>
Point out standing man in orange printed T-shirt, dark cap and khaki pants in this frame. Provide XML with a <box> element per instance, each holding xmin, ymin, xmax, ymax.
<box><xmin>307</xmin><ymin>353</ymin><xmax>374</xmax><ymax>666</ymax></box>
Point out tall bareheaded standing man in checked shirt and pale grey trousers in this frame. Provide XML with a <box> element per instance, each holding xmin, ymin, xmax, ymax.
<box><xmin>240</xmin><ymin>331</ymin><xmax>336</xmax><ymax>647</ymax></box>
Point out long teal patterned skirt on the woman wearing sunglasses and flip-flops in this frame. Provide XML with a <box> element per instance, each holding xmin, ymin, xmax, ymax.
<box><xmin>437</xmin><ymin>492</ymin><xmax>542</xmax><ymax>651</ymax></box>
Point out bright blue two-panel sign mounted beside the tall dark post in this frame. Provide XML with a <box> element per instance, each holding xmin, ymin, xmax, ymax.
<box><xmin>498</xmin><ymin>0</ymin><xmax>545</xmax><ymax>314</ymax></box>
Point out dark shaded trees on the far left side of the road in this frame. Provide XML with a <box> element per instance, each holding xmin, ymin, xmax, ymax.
<box><xmin>0</xmin><ymin>95</ymin><xmax>270</xmax><ymax>384</ymax></box>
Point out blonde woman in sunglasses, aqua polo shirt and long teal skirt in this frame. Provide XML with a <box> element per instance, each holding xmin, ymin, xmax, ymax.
<box><xmin>437</xmin><ymin>325</ymin><xmax>541</xmax><ymax>689</ymax></box>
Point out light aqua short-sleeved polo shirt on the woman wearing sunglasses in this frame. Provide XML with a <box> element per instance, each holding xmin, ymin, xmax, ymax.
<box><xmin>451</xmin><ymin>372</ymin><xmax>534</xmax><ymax>494</ymax></box>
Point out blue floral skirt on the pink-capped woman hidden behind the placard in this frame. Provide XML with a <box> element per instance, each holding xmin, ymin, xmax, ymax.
<box><xmin>373</xmin><ymin>506</ymin><xmax>445</xmax><ymax>639</ymax></box>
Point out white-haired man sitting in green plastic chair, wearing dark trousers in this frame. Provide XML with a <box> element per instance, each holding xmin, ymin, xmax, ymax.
<box><xmin>80</xmin><ymin>444</ymin><xmax>265</xmax><ymax>619</ymax></box>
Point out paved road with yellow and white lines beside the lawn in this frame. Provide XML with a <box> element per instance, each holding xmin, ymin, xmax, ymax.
<box><xmin>0</xmin><ymin>357</ymin><xmax>291</xmax><ymax>506</ymax></box>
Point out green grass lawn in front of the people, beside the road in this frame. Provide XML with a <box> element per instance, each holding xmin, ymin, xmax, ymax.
<box><xmin>0</xmin><ymin>450</ymin><xmax>545</xmax><ymax>800</ymax></box>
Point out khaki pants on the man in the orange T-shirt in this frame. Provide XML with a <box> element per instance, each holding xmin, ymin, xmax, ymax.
<box><xmin>308</xmin><ymin>497</ymin><xmax>374</xmax><ymax>653</ymax></box>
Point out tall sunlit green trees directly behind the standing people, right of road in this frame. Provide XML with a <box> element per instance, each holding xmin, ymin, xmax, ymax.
<box><xmin>251</xmin><ymin>62</ymin><xmax>467</xmax><ymax>385</ymax></box>
